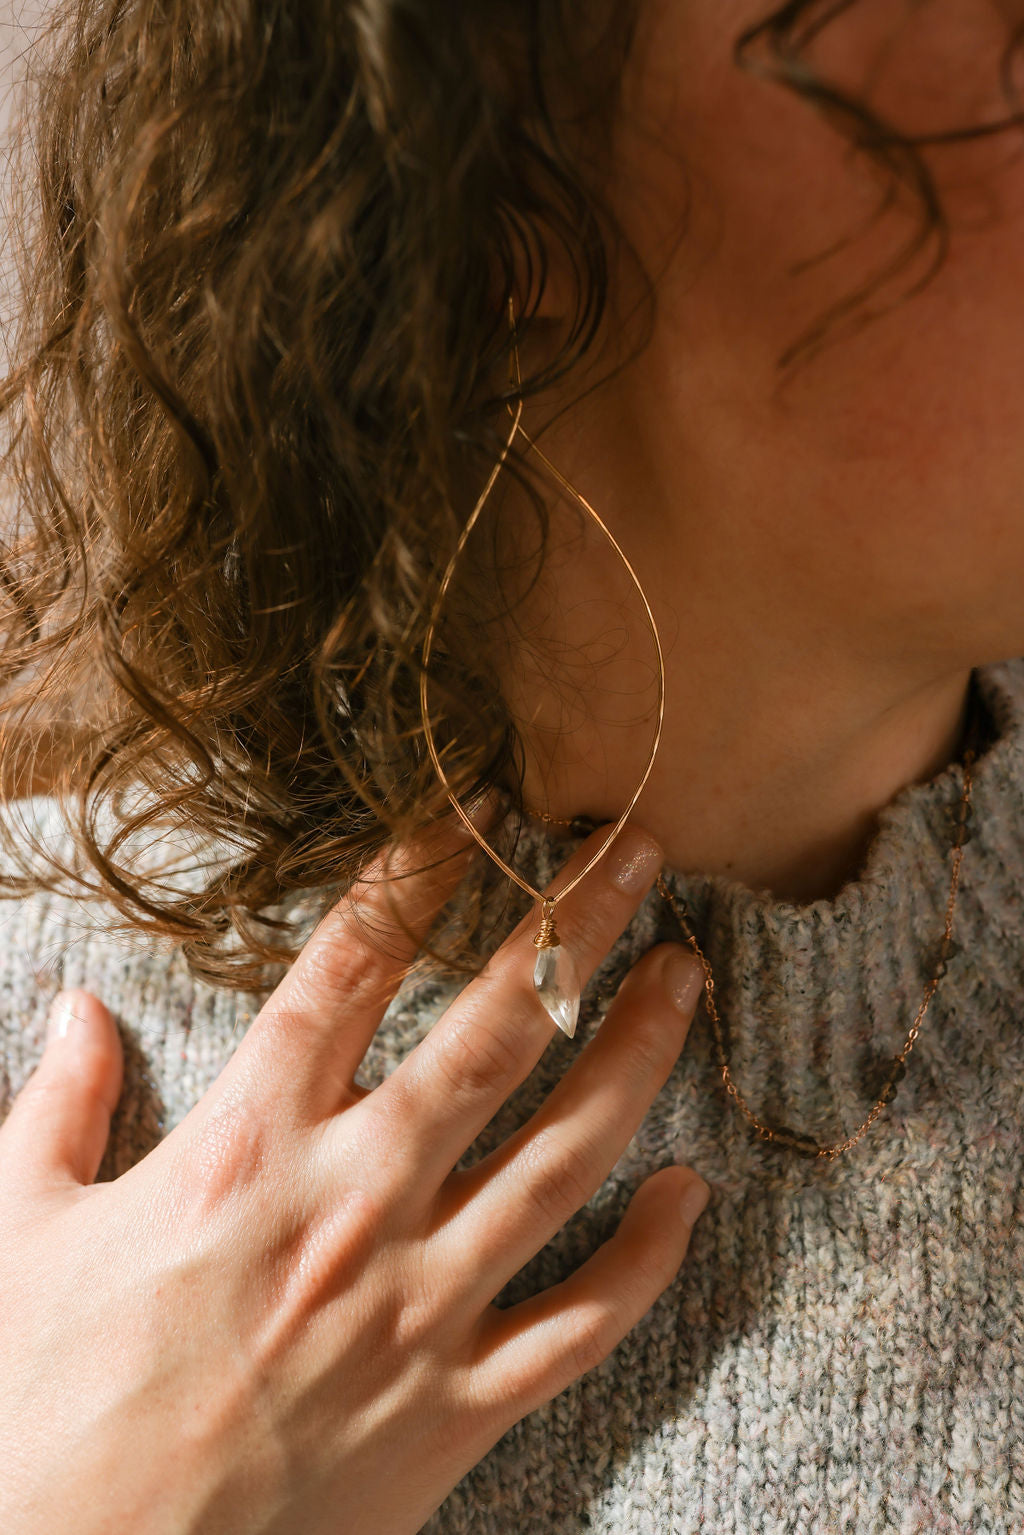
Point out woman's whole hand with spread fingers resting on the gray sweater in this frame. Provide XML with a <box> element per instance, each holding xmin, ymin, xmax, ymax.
<box><xmin>0</xmin><ymin>829</ymin><xmax>706</xmax><ymax>1535</ymax></box>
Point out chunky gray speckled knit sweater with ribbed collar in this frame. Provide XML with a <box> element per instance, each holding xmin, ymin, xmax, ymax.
<box><xmin>0</xmin><ymin>660</ymin><xmax>1024</xmax><ymax>1535</ymax></box>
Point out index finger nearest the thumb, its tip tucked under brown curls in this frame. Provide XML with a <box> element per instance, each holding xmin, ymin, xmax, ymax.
<box><xmin>221</xmin><ymin>803</ymin><xmax>494</xmax><ymax>1124</ymax></box>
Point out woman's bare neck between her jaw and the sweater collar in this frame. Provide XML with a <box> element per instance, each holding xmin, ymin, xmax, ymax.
<box><xmin>502</xmin><ymin>515</ymin><xmax>972</xmax><ymax>904</ymax></box>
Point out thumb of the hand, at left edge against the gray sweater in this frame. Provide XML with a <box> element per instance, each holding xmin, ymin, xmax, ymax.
<box><xmin>0</xmin><ymin>990</ymin><xmax>124</xmax><ymax>1188</ymax></box>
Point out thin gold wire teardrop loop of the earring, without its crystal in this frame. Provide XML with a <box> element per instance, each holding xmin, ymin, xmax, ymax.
<box><xmin>419</xmin><ymin>298</ymin><xmax>665</xmax><ymax>912</ymax></box>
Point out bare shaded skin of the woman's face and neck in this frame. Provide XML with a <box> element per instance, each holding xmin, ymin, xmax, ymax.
<box><xmin>504</xmin><ymin>0</ymin><xmax>1024</xmax><ymax>901</ymax></box>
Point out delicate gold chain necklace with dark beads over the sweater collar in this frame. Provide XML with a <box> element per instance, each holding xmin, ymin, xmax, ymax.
<box><xmin>527</xmin><ymin>749</ymin><xmax>975</xmax><ymax>1160</ymax></box>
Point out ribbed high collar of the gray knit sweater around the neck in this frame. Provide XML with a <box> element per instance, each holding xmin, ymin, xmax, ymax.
<box><xmin>516</xmin><ymin>659</ymin><xmax>1024</xmax><ymax>1141</ymax></box>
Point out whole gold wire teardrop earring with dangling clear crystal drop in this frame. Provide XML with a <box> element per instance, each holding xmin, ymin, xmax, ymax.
<box><xmin>419</xmin><ymin>298</ymin><xmax>665</xmax><ymax>1039</ymax></box>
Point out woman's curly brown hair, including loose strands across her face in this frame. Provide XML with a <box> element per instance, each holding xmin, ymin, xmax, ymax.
<box><xmin>0</xmin><ymin>0</ymin><xmax>1021</xmax><ymax>987</ymax></box>
